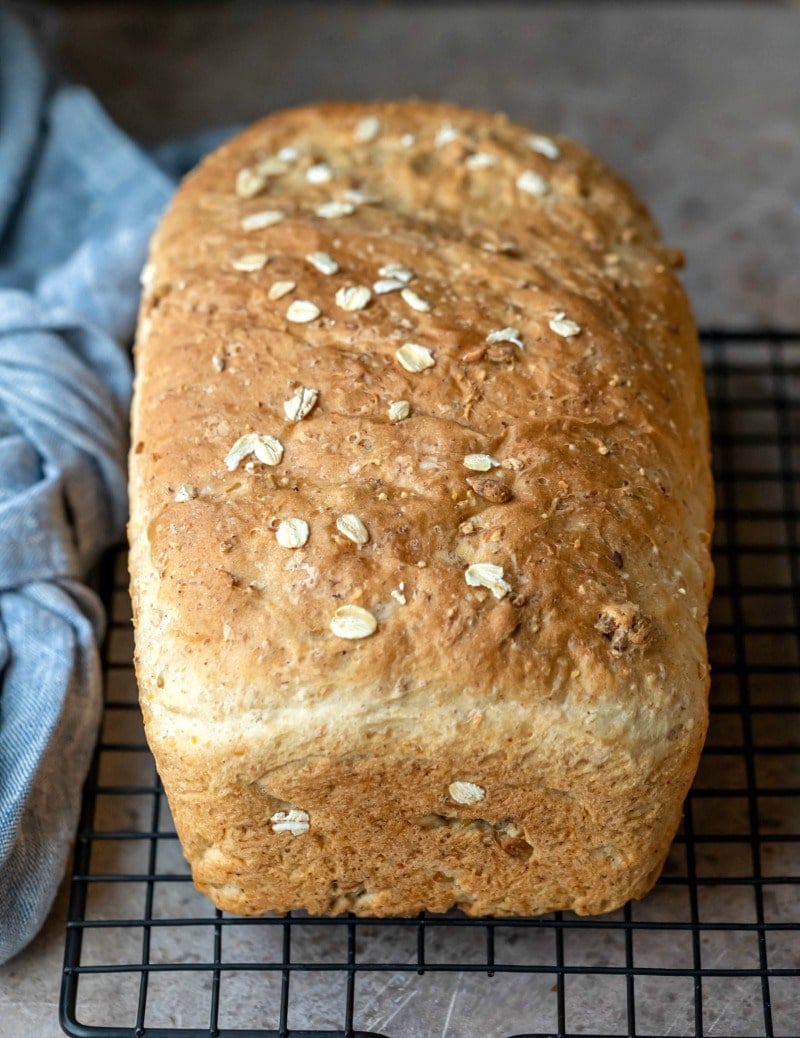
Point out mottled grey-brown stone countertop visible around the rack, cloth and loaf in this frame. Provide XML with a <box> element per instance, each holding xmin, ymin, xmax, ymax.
<box><xmin>0</xmin><ymin>0</ymin><xmax>800</xmax><ymax>1038</ymax></box>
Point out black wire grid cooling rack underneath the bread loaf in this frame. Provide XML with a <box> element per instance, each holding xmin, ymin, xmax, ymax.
<box><xmin>60</xmin><ymin>331</ymin><xmax>800</xmax><ymax>1038</ymax></box>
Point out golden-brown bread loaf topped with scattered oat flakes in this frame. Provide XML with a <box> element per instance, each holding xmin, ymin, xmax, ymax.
<box><xmin>130</xmin><ymin>102</ymin><xmax>712</xmax><ymax>916</ymax></box>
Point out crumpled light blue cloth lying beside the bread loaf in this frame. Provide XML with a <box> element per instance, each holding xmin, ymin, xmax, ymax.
<box><xmin>0</xmin><ymin>11</ymin><xmax>231</xmax><ymax>962</ymax></box>
